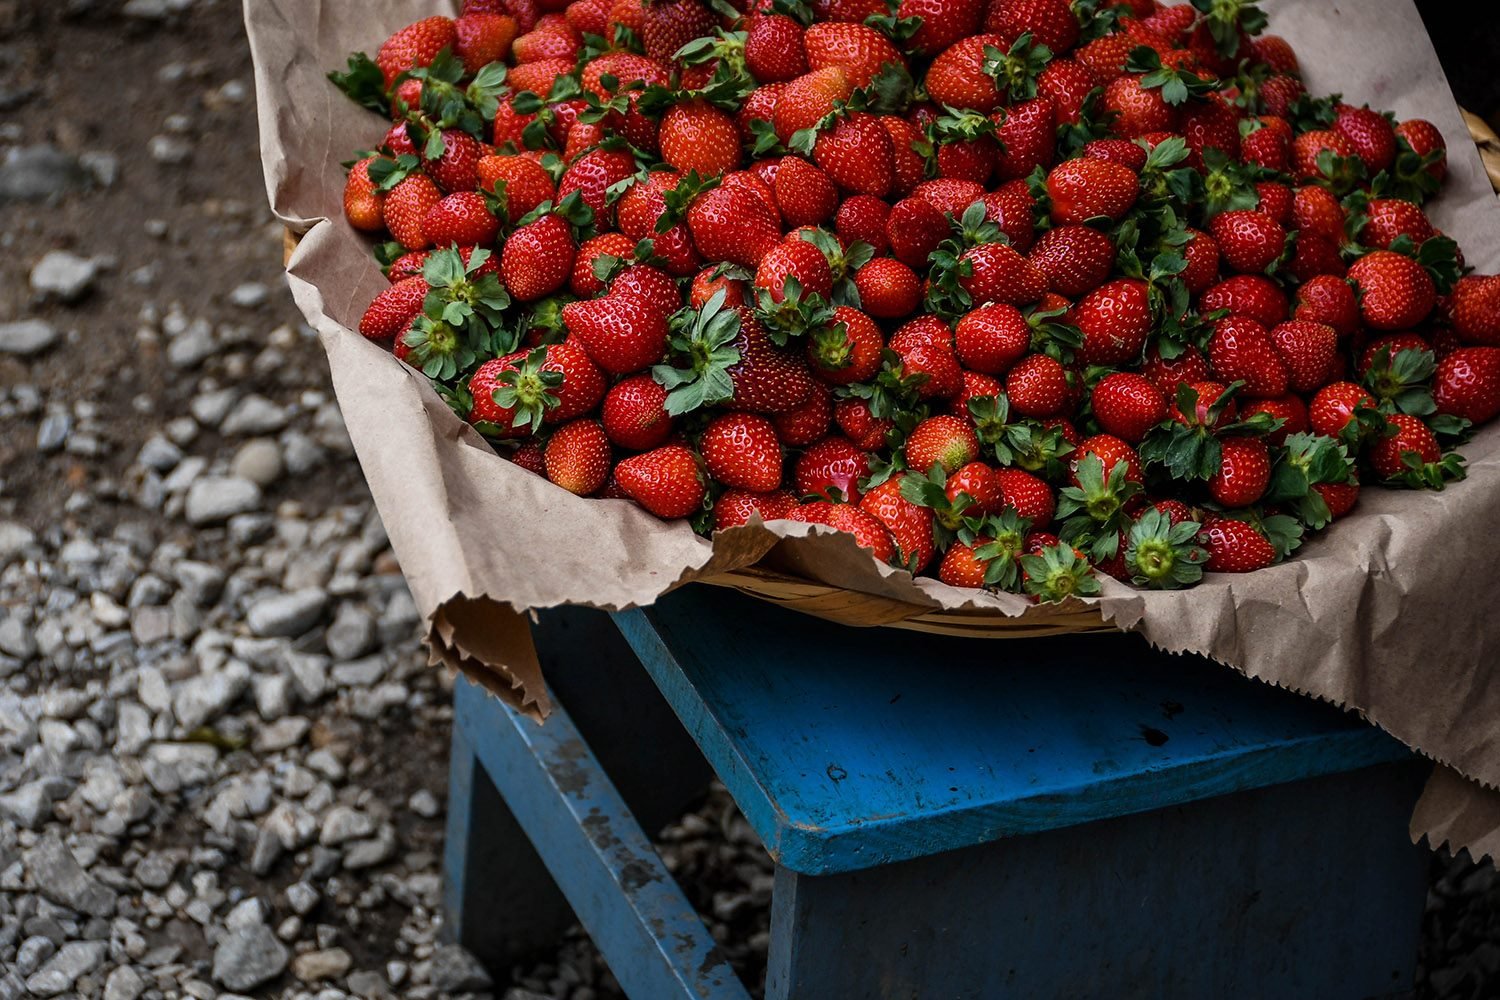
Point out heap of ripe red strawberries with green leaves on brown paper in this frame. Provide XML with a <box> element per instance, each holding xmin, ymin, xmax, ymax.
<box><xmin>330</xmin><ymin>0</ymin><xmax>1500</xmax><ymax>600</ymax></box>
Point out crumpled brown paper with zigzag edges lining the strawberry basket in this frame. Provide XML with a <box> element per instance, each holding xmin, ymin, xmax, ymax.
<box><xmin>246</xmin><ymin>0</ymin><xmax>1500</xmax><ymax>856</ymax></box>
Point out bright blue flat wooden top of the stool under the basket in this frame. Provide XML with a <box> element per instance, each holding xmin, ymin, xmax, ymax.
<box><xmin>614</xmin><ymin>586</ymin><xmax>1410</xmax><ymax>874</ymax></box>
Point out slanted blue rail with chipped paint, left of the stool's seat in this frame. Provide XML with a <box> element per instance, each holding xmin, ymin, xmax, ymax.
<box><xmin>447</xmin><ymin>679</ymin><xmax>749</xmax><ymax>1000</ymax></box>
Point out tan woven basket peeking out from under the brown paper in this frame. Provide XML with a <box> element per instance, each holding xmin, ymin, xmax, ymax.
<box><xmin>284</xmin><ymin>111</ymin><xmax>1500</xmax><ymax>639</ymax></box>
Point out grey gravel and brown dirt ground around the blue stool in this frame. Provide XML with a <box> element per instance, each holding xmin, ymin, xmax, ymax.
<box><xmin>0</xmin><ymin>0</ymin><xmax>1500</xmax><ymax>1000</ymax></box>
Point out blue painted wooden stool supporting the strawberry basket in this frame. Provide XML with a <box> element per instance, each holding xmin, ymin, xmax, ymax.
<box><xmin>446</xmin><ymin>586</ymin><xmax>1425</xmax><ymax>1000</ymax></box>
